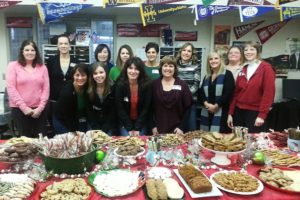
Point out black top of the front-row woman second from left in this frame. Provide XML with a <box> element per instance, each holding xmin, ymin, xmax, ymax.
<box><xmin>87</xmin><ymin>86</ymin><xmax>117</xmax><ymax>132</ymax></box>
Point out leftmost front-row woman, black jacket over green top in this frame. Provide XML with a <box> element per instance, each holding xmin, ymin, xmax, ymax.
<box><xmin>55</xmin><ymin>64</ymin><xmax>89</xmax><ymax>133</ymax></box>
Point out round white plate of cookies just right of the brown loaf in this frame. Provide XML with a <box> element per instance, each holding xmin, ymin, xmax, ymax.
<box><xmin>210</xmin><ymin>171</ymin><xmax>264</xmax><ymax>195</ymax></box>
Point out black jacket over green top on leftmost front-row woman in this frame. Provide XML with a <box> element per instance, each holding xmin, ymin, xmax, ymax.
<box><xmin>54</xmin><ymin>81</ymin><xmax>88</xmax><ymax>131</ymax></box>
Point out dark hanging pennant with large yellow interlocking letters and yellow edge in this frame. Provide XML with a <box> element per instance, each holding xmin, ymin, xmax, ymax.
<box><xmin>140</xmin><ymin>3</ymin><xmax>191</xmax><ymax>26</ymax></box>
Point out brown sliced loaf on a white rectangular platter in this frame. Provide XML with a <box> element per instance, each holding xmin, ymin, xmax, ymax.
<box><xmin>173</xmin><ymin>166</ymin><xmax>223</xmax><ymax>198</ymax></box>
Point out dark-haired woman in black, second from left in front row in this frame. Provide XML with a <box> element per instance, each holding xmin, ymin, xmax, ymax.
<box><xmin>87</xmin><ymin>62</ymin><xmax>116</xmax><ymax>135</ymax></box>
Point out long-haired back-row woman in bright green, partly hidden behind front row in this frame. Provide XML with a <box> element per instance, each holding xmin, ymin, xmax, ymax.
<box><xmin>109</xmin><ymin>44</ymin><xmax>133</xmax><ymax>81</ymax></box>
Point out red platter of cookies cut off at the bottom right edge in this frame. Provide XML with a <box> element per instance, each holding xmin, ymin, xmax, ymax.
<box><xmin>258</xmin><ymin>167</ymin><xmax>300</xmax><ymax>194</ymax></box>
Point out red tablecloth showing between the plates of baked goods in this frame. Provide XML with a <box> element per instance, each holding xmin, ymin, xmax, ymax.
<box><xmin>0</xmin><ymin>141</ymin><xmax>300</xmax><ymax>200</ymax></box>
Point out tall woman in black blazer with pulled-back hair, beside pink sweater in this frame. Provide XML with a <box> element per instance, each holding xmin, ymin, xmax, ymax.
<box><xmin>46</xmin><ymin>35</ymin><xmax>77</xmax><ymax>134</ymax></box>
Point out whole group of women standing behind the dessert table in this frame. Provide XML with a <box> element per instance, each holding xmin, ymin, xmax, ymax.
<box><xmin>6</xmin><ymin>35</ymin><xmax>275</xmax><ymax>137</ymax></box>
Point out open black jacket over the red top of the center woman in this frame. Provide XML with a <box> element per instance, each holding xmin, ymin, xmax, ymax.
<box><xmin>115</xmin><ymin>80</ymin><xmax>152</xmax><ymax>131</ymax></box>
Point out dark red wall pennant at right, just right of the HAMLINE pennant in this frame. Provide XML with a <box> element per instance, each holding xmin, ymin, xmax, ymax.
<box><xmin>256</xmin><ymin>20</ymin><xmax>289</xmax><ymax>44</ymax></box>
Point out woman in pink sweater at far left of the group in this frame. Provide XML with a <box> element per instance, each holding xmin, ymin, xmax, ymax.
<box><xmin>6</xmin><ymin>40</ymin><xmax>49</xmax><ymax>137</ymax></box>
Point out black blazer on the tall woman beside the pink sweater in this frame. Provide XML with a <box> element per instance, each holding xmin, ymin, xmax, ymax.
<box><xmin>47</xmin><ymin>55</ymin><xmax>77</xmax><ymax>101</ymax></box>
